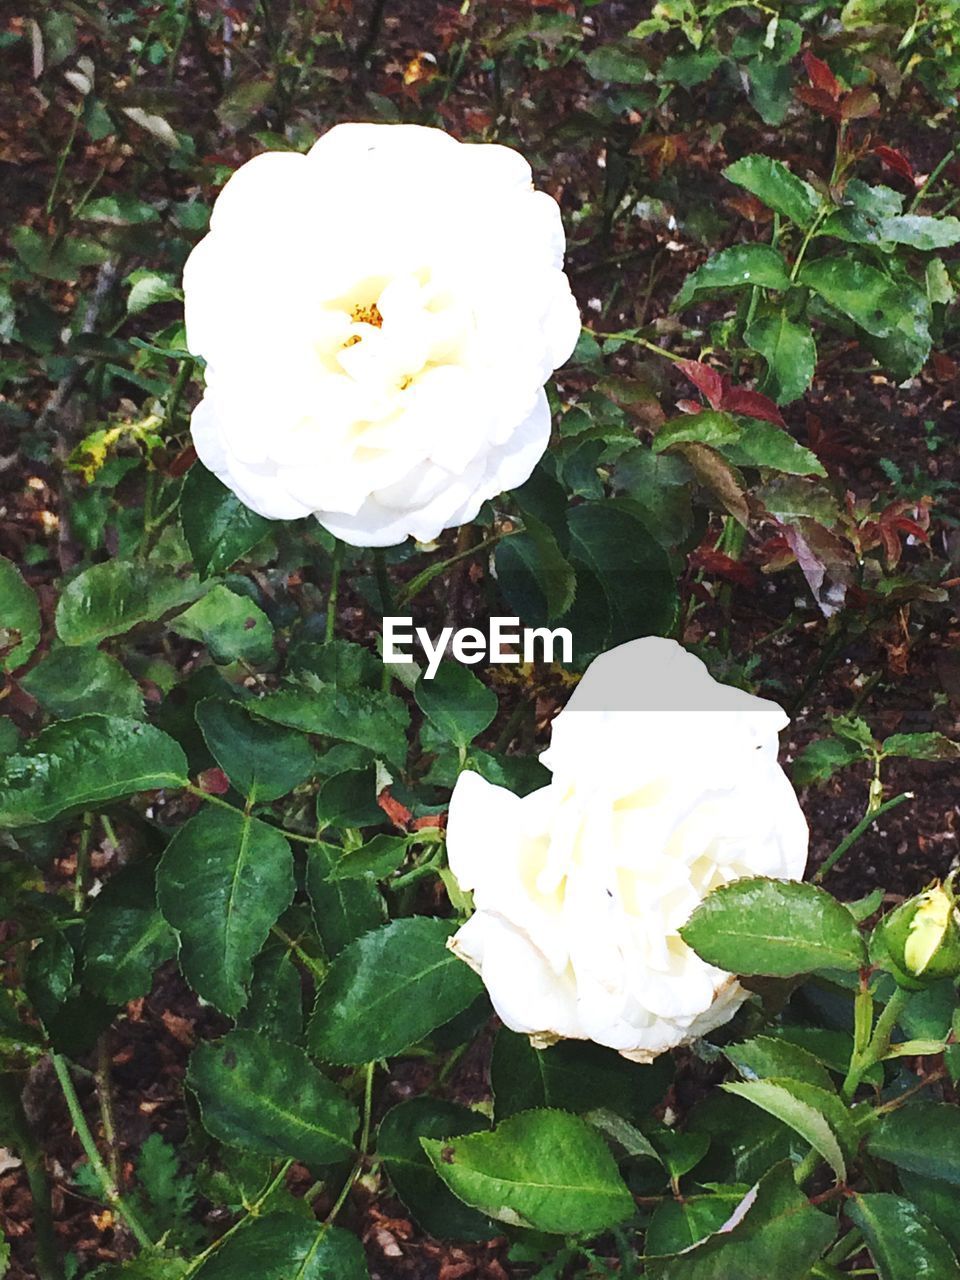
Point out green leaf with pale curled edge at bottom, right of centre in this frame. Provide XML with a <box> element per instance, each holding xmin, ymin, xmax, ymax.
<box><xmin>644</xmin><ymin>1161</ymin><xmax>837</xmax><ymax>1280</ymax></box>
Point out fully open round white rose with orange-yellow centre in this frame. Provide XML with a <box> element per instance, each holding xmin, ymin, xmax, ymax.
<box><xmin>183</xmin><ymin>124</ymin><xmax>580</xmax><ymax>547</ymax></box>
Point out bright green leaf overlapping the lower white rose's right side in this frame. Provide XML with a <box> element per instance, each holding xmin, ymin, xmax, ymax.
<box><xmin>680</xmin><ymin>877</ymin><xmax>867</xmax><ymax>978</ymax></box>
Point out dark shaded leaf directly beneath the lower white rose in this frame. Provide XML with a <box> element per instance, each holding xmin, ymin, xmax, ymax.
<box><xmin>490</xmin><ymin>1027</ymin><xmax>673</xmax><ymax>1121</ymax></box>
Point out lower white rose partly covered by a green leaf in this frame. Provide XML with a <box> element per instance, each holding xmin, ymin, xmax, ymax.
<box><xmin>447</xmin><ymin>639</ymin><xmax>808</xmax><ymax>1062</ymax></box>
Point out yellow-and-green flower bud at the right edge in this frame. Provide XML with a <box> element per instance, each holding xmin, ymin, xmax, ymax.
<box><xmin>877</xmin><ymin>882</ymin><xmax>960</xmax><ymax>987</ymax></box>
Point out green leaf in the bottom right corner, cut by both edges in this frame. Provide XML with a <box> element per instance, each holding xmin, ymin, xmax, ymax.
<box><xmin>846</xmin><ymin>1192</ymin><xmax>960</xmax><ymax>1280</ymax></box>
